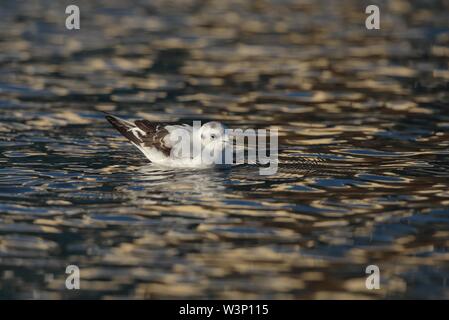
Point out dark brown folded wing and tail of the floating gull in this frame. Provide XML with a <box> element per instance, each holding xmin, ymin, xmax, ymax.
<box><xmin>106</xmin><ymin>115</ymin><xmax>171</xmax><ymax>156</ymax></box>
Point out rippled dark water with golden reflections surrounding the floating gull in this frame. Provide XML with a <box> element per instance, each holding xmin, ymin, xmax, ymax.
<box><xmin>0</xmin><ymin>0</ymin><xmax>449</xmax><ymax>299</ymax></box>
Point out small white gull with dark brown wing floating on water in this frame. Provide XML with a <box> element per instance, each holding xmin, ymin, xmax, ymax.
<box><xmin>106</xmin><ymin>114</ymin><xmax>229</xmax><ymax>168</ymax></box>
